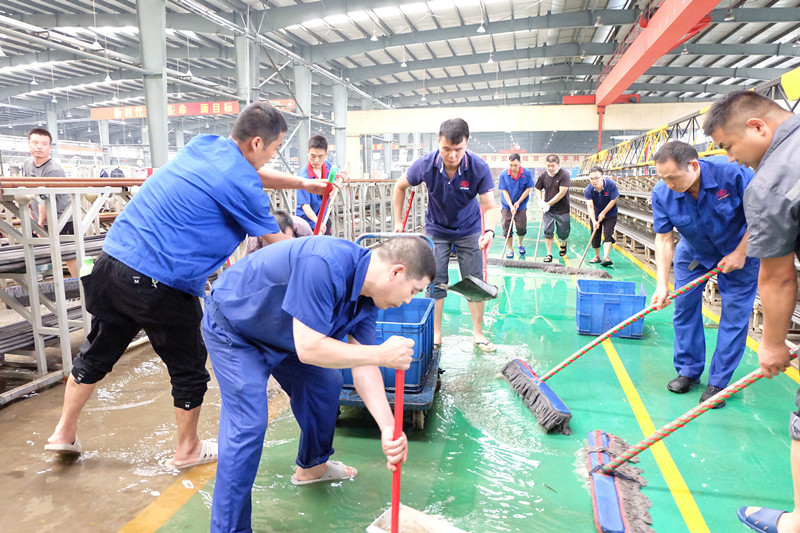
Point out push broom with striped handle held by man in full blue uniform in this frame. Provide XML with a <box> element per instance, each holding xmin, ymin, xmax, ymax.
<box><xmin>503</xmin><ymin>266</ymin><xmax>722</xmax><ymax>435</ymax></box>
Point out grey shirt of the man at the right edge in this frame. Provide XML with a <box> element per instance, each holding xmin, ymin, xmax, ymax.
<box><xmin>744</xmin><ymin>115</ymin><xmax>800</xmax><ymax>258</ymax></box>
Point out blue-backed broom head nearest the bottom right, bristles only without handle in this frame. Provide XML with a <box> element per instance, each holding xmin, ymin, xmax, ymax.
<box><xmin>585</xmin><ymin>430</ymin><xmax>654</xmax><ymax>533</ymax></box>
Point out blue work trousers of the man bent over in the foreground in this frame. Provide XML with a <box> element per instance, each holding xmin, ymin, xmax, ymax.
<box><xmin>203</xmin><ymin>300</ymin><xmax>342</xmax><ymax>533</ymax></box>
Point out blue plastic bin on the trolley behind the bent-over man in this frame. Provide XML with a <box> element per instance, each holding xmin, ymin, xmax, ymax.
<box><xmin>341</xmin><ymin>298</ymin><xmax>434</xmax><ymax>392</ymax></box>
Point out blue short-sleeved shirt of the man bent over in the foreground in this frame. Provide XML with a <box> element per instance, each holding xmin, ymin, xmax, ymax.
<box><xmin>206</xmin><ymin>236</ymin><xmax>378</xmax><ymax>352</ymax></box>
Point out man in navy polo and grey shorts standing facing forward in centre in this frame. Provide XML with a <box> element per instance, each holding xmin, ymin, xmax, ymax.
<box><xmin>392</xmin><ymin>118</ymin><xmax>497</xmax><ymax>352</ymax></box>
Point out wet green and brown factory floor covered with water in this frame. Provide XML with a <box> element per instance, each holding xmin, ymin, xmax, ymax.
<box><xmin>0</xmin><ymin>214</ymin><xmax>797</xmax><ymax>533</ymax></box>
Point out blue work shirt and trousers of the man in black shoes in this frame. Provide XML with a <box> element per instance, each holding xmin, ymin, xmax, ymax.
<box><xmin>652</xmin><ymin>158</ymin><xmax>760</xmax><ymax>388</ymax></box>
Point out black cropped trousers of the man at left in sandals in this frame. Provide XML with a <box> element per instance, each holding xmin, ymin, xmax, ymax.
<box><xmin>72</xmin><ymin>253</ymin><xmax>210</xmax><ymax>410</ymax></box>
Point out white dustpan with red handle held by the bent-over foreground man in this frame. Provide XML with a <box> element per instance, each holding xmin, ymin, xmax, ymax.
<box><xmin>367</xmin><ymin>370</ymin><xmax>465</xmax><ymax>533</ymax></box>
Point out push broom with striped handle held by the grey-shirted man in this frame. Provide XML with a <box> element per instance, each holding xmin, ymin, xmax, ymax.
<box><xmin>584</xmin><ymin>352</ymin><xmax>797</xmax><ymax>533</ymax></box>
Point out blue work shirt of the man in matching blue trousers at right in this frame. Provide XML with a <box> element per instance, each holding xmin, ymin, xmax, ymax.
<box><xmin>652</xmin><ymin>158</ymin><xmax>753</xmax><ymax>268</ymax></box>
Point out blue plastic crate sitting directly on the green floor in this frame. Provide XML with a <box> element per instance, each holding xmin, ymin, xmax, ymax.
<box><xmin>575</xmin><ymin>279</ymin><xmax>647</xmax><ymax>339</ymax></box>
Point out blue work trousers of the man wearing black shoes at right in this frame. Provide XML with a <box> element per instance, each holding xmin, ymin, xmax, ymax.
<box><xmin>672</xmin><ymin>246</ymin><xmax>761</xmax><ymax>388</ymax></box>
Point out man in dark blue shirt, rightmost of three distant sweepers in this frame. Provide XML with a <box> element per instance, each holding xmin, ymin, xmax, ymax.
<box><xmin>583</xmin><ymin>167</ymin><xmax>619</xmax><ymax>267</ymax></box>
